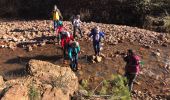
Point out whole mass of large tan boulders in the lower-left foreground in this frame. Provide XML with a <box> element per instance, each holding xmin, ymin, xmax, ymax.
<box><xmin>2</xmin><ymin>60</ymin><xmax>78</xmax><ymax>100</ymax></box>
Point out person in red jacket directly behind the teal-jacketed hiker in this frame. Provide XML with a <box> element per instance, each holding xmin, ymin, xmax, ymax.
<box><xmin>61</xmin><ymin>31</ymin><xmax>74</xmax><ymax>62</ymax></box>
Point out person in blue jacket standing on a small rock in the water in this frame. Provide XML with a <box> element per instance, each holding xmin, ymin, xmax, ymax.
<box><xmin>89</xmin><ymin>26</ymin><xmax>104</xmax><ymax>56</ymax></box>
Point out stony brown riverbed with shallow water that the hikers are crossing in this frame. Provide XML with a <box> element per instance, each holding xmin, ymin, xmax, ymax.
<box><xmin>0</xmin><ymin>20</ymin><xmax>170</xmax><ymax>100</ymax></box>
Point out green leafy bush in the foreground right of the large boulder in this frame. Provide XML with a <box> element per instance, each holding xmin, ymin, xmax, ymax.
<box><xmin>79</xmin><ymin>75</ymin><xmax>131</xmax><ymax>100</ymax></box>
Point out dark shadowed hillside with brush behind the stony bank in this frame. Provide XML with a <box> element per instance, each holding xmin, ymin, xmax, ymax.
<box><xmin>0</xmin><ymin>0</ymin><xmax>170</xmax><ymax>32</ymax></box>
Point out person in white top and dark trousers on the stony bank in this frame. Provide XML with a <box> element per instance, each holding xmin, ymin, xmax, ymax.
<box><xmin>73</xmin><ymin>15</ymin><xmax>83</xmax><ymax>38</ymax></box>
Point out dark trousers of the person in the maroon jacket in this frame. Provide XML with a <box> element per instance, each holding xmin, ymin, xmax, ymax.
<box><xmin>125</xmin><ymin>73</ymin><xmax>137</xmax><ymax>92</ymax></box>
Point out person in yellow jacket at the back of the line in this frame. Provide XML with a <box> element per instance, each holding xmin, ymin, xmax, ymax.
<box><xmin>52</xmin><ymin>5</ymin><xmax>63</xmax><ymax>31</ymax></box>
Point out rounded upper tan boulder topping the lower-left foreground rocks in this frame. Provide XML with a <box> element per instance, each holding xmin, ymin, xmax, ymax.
<box><xmin>27</xmin><ymin>60</ymin><xmax>78</xmax><ymax>95</ymax></box>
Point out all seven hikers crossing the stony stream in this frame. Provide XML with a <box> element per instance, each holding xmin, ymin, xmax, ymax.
<box><xmin>53</xmin><ymin>5</ymin><xmax>140</xmax><ymax>91</ymax></box>
